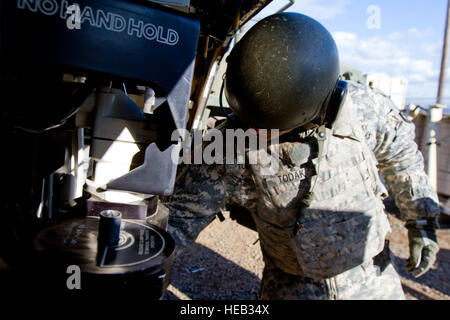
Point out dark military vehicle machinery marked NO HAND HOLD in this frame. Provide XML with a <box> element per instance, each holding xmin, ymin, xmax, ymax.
<box><xmin>0</xmin><ymin>0</ymin><xmax>271</xmax><ymax>299</ymax></box>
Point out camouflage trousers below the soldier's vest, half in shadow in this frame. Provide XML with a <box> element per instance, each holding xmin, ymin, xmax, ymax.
<box><xmin>260</xmin><ymin>245</ymin><xmax>405</xmax><ymax>300</ymax></box>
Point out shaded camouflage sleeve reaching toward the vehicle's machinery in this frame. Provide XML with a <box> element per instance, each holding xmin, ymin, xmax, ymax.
<box><xmin>160</xmin><ymin>164</ymin><xmax>226</xmax><ymax>252</ymax></box>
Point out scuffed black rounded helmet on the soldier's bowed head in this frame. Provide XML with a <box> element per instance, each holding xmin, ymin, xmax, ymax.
<box><xmin>225</xmin><ymin>13</ymin><xmax>339</xmax><ymax>130</ymax></box>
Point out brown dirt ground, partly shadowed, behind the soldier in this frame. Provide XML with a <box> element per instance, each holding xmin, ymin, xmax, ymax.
<box><xmin>162</xmin><ymin>199</ymin><xmax>450</xmax><ymax>300</ymax></box>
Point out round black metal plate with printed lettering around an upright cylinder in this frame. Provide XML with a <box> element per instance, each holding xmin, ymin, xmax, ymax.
<box><xmin>35</xmin><ymin>217</ymin><xmax>175</xmax><ymax>274</ymax></box>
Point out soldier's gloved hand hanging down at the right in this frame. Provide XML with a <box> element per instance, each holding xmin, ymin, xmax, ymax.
<box><xmin>405</xmin><ymin>220</ymin><xmax>439</xmax><ymax>278</ymax></box>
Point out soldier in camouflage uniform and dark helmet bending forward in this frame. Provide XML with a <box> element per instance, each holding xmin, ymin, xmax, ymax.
<box><xmin>161</xmin><ymin>13</ymin><xmax>439</xmax><ymax>299</ymax></box>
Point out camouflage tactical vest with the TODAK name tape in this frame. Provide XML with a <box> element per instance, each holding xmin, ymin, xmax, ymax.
<box><xmin>246</xmin><ymin>96</ymin><xmax>390</xmax><ymax>279</ymax></box>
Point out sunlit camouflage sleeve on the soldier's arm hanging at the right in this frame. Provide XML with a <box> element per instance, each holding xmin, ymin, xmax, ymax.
<box><xmin>357</xmin><ymin>84</ymin><xmax>439</xmax><ymax>221</ymax></box>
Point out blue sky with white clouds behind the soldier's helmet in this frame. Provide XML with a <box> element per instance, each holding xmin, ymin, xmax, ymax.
<box><xmin>251</xmin><ymin>0</ymin><xmax>450</xmax><ymax>105</ymax></box>
